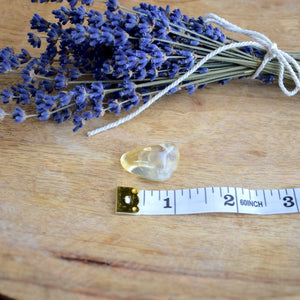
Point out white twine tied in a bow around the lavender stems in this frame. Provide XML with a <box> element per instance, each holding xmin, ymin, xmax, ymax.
<box><xmin>87</xmin><ymin>13</ymin><xmax>300</xmax><ymax>136</ymax></box>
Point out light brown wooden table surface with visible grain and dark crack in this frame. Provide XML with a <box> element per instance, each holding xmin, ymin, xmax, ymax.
<box><xmin>0</xmin><ymin>0</ymin><xmax>300</xmax><ymax>300</ymax></box>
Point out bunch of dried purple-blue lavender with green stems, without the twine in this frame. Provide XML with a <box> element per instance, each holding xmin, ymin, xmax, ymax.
<box><xmin>0</xmin><ymin>0</ymin><xmax>300</xmax><ymax>131</ymax></box>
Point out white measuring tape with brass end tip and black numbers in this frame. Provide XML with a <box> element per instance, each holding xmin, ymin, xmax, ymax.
<box><xmin>116</xmin><ymin>187</ymin><xmax>300</xmax><ymax>215</ymax></box>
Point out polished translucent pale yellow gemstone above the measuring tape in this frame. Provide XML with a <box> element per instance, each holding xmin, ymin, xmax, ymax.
<box><xmin>121</xmin><ymin>143</ymin><xmax>179</xmax><ymax>181</ymax></box>
